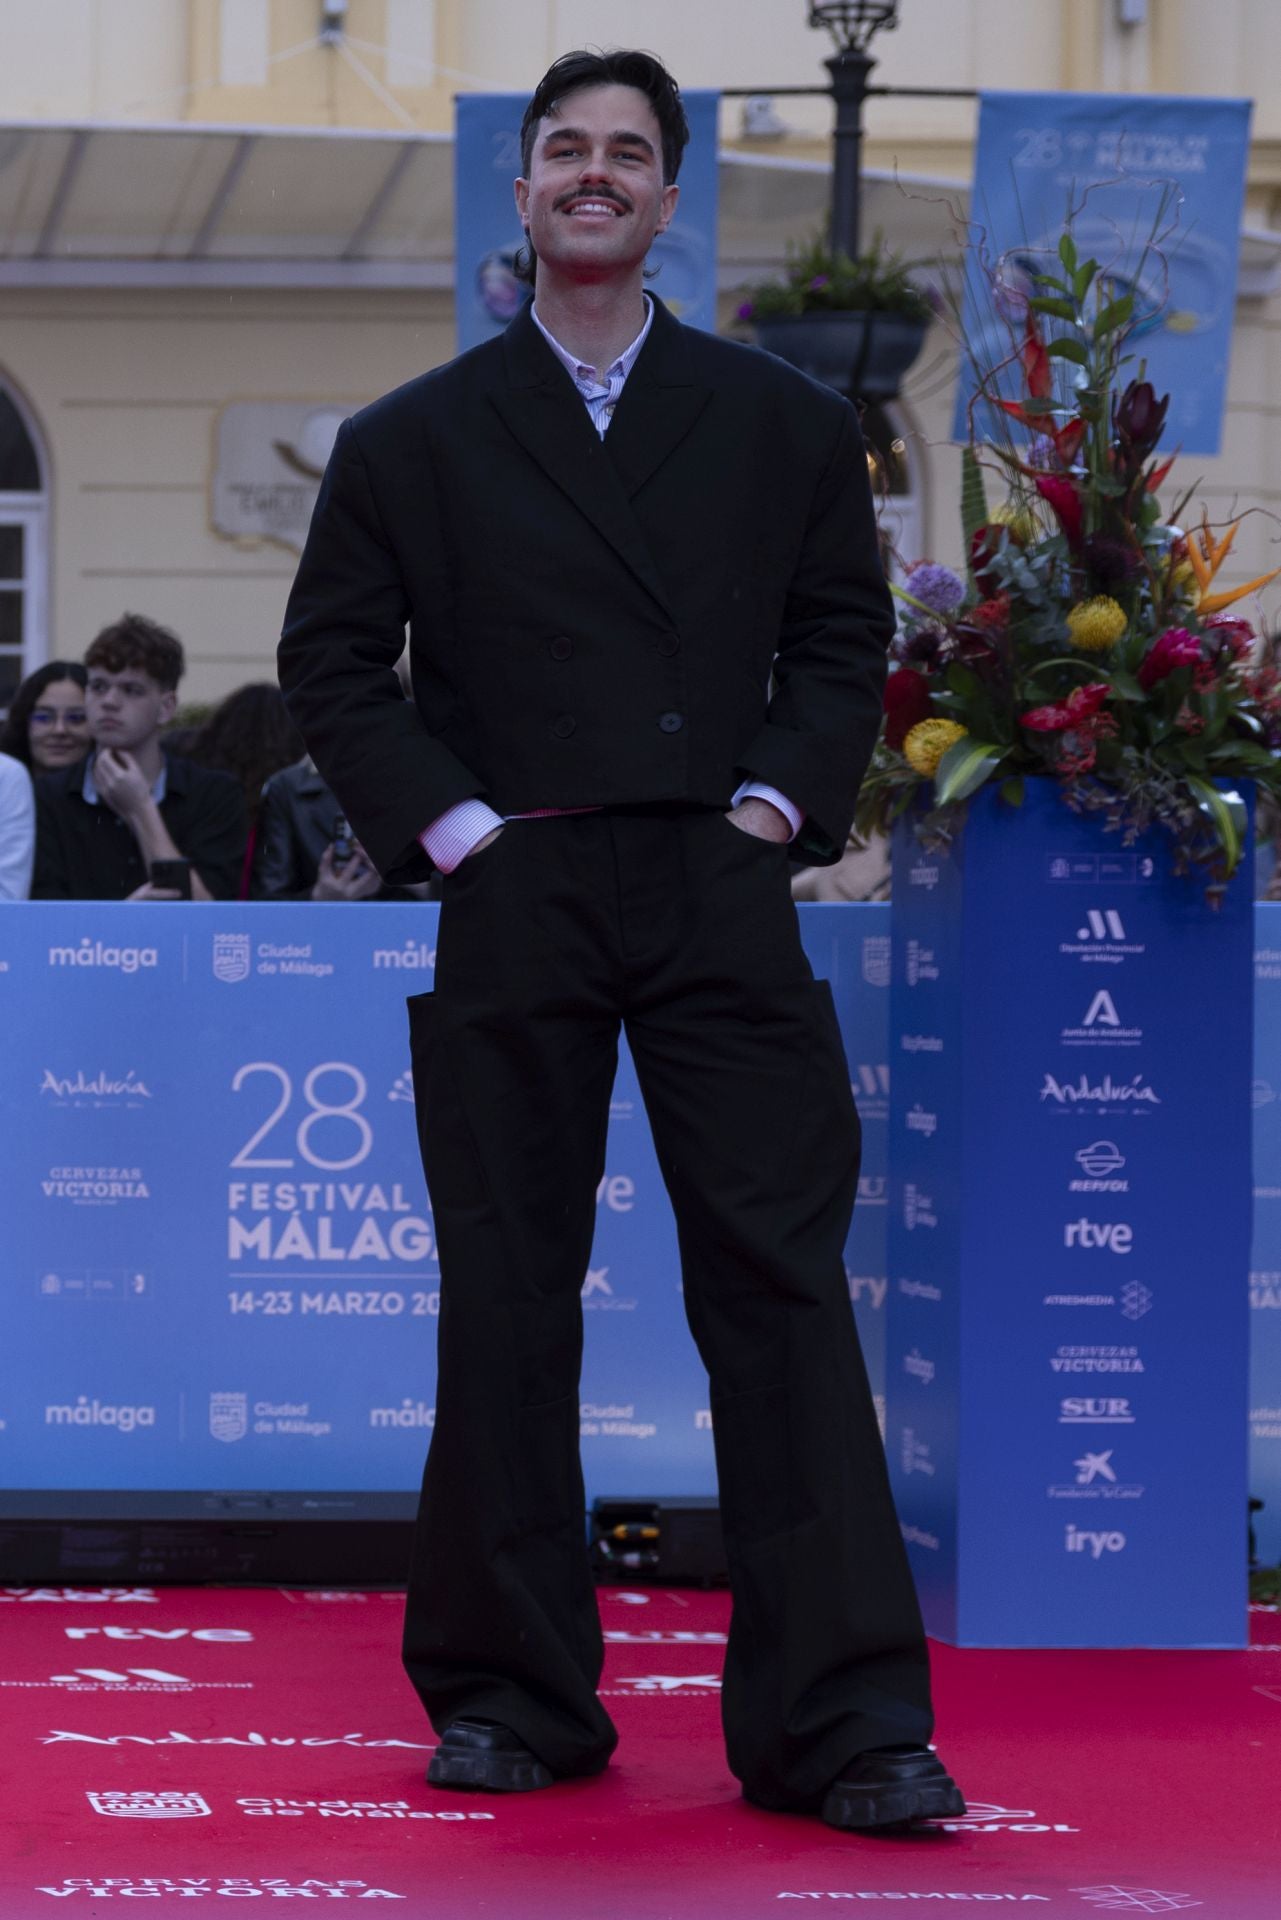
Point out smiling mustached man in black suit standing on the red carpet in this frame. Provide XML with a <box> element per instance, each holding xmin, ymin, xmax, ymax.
<box><xmin>280</xmin><ymin>54</ymin><xmax>964</xmax><ymax>1828</ymax></box>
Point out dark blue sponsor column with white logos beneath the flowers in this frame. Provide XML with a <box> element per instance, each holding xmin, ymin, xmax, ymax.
<box><xmin>887</xmin><ymin>781</ymin><xmax>1252</xmax><ymax>1645</ymax></box>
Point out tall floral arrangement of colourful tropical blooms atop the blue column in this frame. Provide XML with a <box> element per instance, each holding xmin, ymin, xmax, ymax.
<box><xmin>857</xmin><ymin>232</ymin><xmax>1281</xmax><ymax>900</ymax></box>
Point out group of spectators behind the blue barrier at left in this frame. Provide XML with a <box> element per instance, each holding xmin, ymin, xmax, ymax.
<box><xmin>0</xmin><ymin>612</ymin><xmax>430</xmax><ymax>900</ymax></box>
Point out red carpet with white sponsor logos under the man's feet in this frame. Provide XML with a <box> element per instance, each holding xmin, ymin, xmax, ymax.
<box><xmin>0</xmin><ymin>1588</ymin><xmax>1281</xmax><ymax>1920</ymax></box>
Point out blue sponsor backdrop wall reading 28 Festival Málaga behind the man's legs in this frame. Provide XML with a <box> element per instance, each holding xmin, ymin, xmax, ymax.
<box><xmin>0</xmin><ymin>904</ymin><xmax>1281</xmax><ymax>1561</ymax></box>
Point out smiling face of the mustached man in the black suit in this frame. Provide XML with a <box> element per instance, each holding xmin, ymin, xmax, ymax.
<box><xmin>517</xmin><ymin>86</ymin><xmax>680</xmax><ymax>280</ymax></box>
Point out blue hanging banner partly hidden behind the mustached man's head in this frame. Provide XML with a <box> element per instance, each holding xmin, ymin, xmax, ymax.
<box><xmin>453</xmin><ymin>88</ymin><xmax>720</xmax><ymax>353</ymax></box>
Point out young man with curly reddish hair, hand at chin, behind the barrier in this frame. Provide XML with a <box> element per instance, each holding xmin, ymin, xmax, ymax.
<box><xmin>31</xmin><ymin>612</ymin><xmax>248</xmax><ymax>900</ymax></box>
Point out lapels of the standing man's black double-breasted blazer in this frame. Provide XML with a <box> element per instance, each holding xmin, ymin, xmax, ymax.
<box><xmin>490</xmin><ymin>301</ymin><xmax>709</xmax><ymax>618</ymax></box>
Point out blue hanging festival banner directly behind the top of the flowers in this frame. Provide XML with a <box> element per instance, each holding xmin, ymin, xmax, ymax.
<box><xmin>953</xmin><ymin>92</ymin><xmax>1250</xmax><ymax>453</ymax></box>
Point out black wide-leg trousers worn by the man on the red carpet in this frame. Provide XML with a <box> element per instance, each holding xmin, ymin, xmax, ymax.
<box><xmin>403</xmin><ymin>810</ymin><xmax>933</xmax><ymax>1807</ymax></box>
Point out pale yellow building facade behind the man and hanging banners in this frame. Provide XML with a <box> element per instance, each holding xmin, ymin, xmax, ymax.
<box><xmin>0</xmin><ymin>0</ymin><xmax>1281</xmax><ymax>703</ymax></box>
